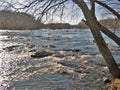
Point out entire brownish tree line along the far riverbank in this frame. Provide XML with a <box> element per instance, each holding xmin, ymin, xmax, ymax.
<box><xmin>0</xmin><ymin>10</ymin><xmax>120</xmax><ymax>29</ymax></box>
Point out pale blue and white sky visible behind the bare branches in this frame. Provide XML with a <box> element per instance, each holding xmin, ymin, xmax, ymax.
<box><xmin>0</xmin><ymin>0</ymin><xmax>117</xmax><ymax>24</ymax></box>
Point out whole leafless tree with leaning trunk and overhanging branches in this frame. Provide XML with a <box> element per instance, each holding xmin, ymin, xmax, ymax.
<box><xmin>0</xmin><ymin>0</ymin><xmax>120</xmax><ymax>88</ymax></box>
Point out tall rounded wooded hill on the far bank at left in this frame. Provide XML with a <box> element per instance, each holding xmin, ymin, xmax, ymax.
<box><xmin>0</xmin><ymin>10</ymin><xmax>43</xmax><ymax>29</ymax></box>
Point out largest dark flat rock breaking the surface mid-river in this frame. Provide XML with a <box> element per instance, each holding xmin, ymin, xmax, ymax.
<box><xmin>31</xmin><ymin>51</ymin><xmax>53</xmax><ymax>58</ymax></box>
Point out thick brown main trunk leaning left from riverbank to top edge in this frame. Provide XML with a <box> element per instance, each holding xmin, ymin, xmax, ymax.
<box><xmin>73</xmin><ymin>0</ymin><xmax>120</xmax><ymax>78</ymax></box>
